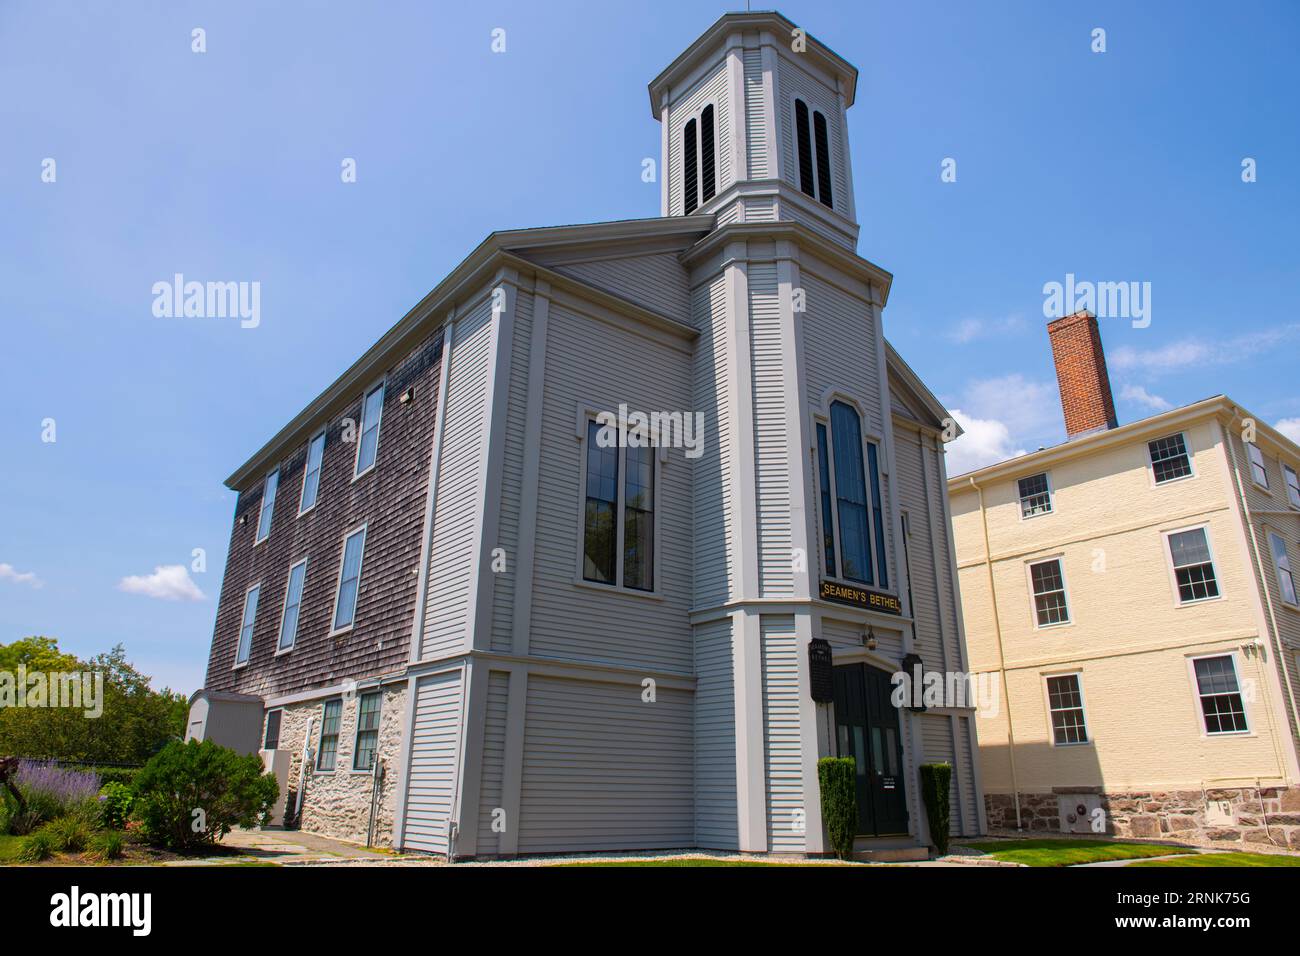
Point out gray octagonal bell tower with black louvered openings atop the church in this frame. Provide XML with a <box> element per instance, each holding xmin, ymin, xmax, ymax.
<box><xmin>650</xmin><ymin>13</ymin><xmax>858</xmax><ymax>248</ymax></box>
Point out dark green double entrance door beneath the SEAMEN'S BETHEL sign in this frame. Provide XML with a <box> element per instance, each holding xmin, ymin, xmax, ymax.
<box><xmin>833</xmin><ymin>663</ymin><xmax>907</xmax><ymax>836</ymax></box>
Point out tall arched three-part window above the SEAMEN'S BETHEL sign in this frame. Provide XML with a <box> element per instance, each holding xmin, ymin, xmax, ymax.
<box><xmin>816</xmin><ymin>402</ymin><xmax>889</xmax><ymax>588</ymax></box>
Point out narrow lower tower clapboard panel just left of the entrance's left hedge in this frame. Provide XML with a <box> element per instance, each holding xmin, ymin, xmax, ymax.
<box><xmin>759</xmin><ymin>615</ymin><xmax>807</xmax><ymax>852</ymax></box>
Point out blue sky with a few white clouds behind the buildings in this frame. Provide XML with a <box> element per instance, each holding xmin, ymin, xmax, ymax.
<box><xmin>0</xmin><ymin>0</ymin><xmax>1300</xmax><ymax>692</ymax></box>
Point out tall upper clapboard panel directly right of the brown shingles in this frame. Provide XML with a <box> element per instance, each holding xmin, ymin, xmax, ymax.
<box><xmin>420</xmin><ymin>303</ymin><xmax>491</xmax><ymax>658</ymax></box>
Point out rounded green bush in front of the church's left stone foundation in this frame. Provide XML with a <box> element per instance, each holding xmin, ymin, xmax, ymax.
<box><xmin>133</xmin><ymin>740</ymin><xmax>280</xmax><ymax>852</ymax></box>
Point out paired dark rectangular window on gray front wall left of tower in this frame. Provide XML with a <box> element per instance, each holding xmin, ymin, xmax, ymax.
<box><xmin>582</xmin><ymin>421</ymin><xmax>655</xmax><ymax>591</ymax></box>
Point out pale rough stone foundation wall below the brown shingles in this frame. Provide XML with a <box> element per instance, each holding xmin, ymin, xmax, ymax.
<box><xmin>280</xmin><ymin>684</ymin><xmax>406</xmax><ymax>847</ymax></box>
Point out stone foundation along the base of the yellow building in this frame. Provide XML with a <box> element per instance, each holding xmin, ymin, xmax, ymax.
<box><xmin>984</xmin><ymin>787</ymin><xmax>1300</xmax><ymax>849</ymax></box>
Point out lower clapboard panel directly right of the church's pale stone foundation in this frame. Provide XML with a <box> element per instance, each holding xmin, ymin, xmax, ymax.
<box><xmin>403</xmin><ymin>670</ymin><xmax>473</xmax><ymax>853</ymax></box>
